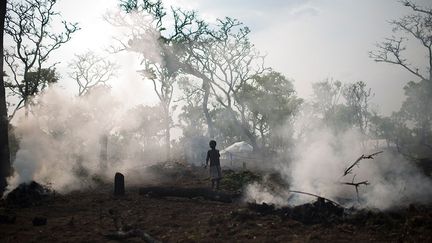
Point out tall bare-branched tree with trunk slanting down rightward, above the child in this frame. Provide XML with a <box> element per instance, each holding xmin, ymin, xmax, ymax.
<box><xmin>194</xmin><ymin>17</ymin><xmax>267</xmax><ymax>149</ymax></box>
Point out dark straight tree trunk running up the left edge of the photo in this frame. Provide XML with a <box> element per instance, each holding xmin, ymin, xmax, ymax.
<box><xmin>0</xmin><ymin>0</ymin><xmax>11</xmax><ymax>197</ymax></box>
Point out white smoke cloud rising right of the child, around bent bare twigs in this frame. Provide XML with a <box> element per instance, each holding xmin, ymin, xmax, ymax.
<box><xmin>246</xmin><ymin>107</ymin><xmax>432</xmax><ymax>209</ymax></box>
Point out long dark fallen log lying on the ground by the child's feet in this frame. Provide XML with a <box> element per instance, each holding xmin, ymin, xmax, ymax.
<box><xmin>139</xmin><ymin>186</ymin><xmax>240</xmax><ymax>203</ymax></box>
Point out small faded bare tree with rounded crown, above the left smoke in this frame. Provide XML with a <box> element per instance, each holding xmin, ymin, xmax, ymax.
<box><xmin>69</xmin><ymin>51</ymin><xmax>118</xmax><ymax>96</ymax></box>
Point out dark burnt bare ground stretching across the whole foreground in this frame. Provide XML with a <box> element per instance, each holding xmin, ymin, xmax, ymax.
<box><xmin>0</xmin><ymin>162</ymin><xmax>432</xmax><ymax>242</ymax></box>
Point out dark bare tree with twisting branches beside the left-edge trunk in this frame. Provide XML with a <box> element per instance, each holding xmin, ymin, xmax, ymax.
<box><xmin>5</xmin><ymin>0</ymin><xmax>79</xmax><ymax>117</ymax></box>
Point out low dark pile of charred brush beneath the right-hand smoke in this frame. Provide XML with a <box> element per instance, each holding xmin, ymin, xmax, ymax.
<box><xmin>235</xmin><ymin>198</ymin><xmax>432</xmax><ymax>232</ymax></box>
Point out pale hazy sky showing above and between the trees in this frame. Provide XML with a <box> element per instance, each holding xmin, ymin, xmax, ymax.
<box><xmin>48</xmin><ymin>0</ymin><xmax>432</xmax><ymax>114</ymax></box>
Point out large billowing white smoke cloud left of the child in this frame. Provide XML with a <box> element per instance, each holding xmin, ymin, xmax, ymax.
<box><xmin>8</xmin><ymin>86</ymin><xmax>169</xmax><ymax>192</ymax></box>
